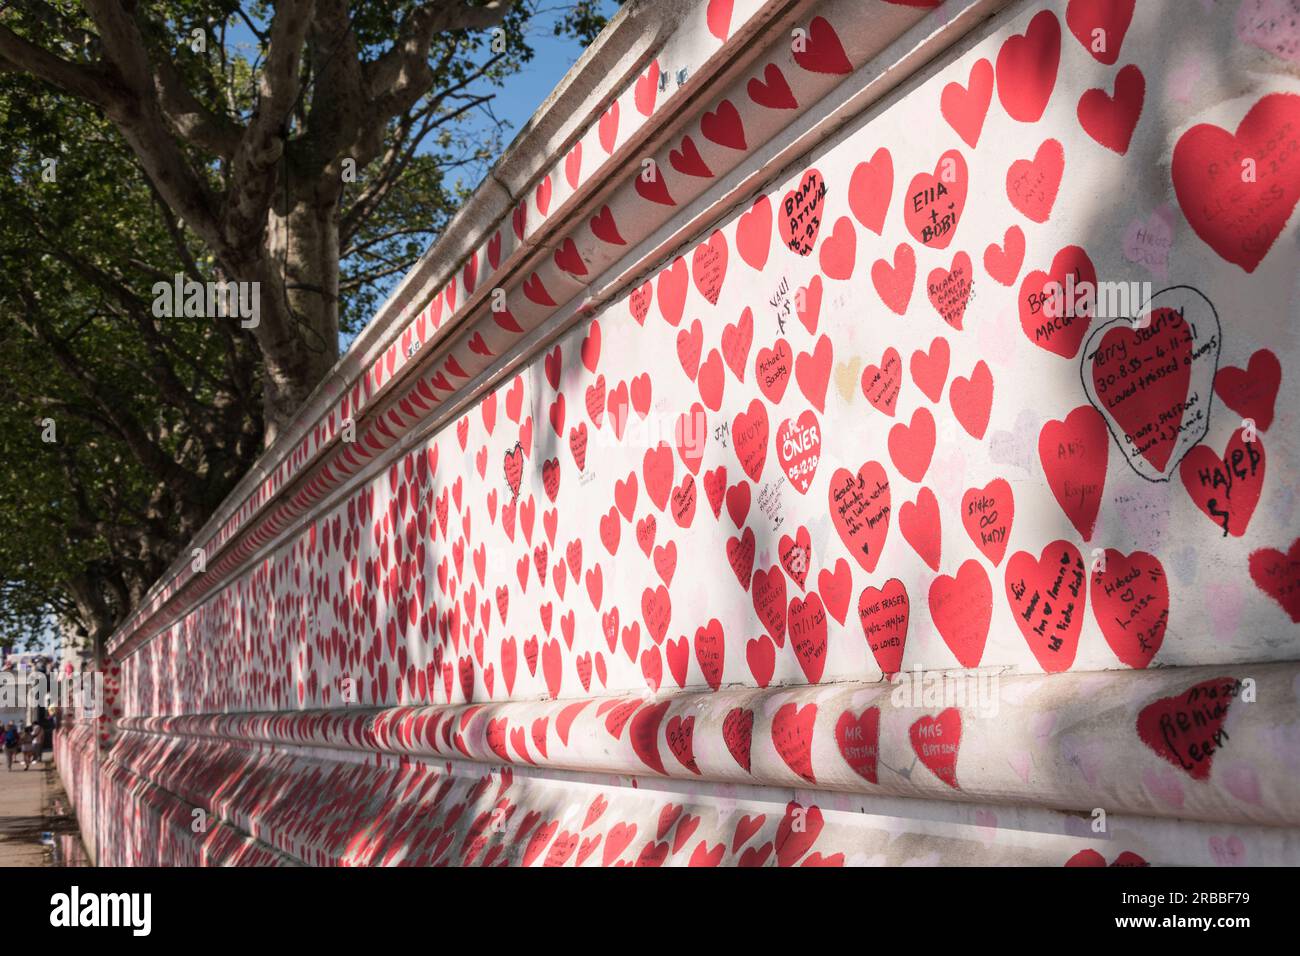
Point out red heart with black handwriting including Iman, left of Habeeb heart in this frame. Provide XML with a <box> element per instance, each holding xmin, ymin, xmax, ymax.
<box><xmin>1006</xmin><ymin>541</ymin><xmax>1087</xmax><ymax>674</ymax></box>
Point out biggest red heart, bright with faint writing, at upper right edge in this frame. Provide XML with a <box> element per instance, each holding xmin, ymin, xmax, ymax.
<box><xmin>1170</xmin><ymin>92</ymin><xmax>1300</xmax><ymax>272</ymax></box>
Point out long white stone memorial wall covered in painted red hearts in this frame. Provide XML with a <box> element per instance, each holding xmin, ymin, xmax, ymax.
<box><xmin>59</xmin><ymin>0</ymin><xmax>1300</xmax><ymax>866</ymax></box>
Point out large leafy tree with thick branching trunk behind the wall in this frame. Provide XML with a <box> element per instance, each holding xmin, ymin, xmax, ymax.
<box><xmin>0</xmin><ymin>0</ymin><xmax>606</xmax><ymax>650</ymax></box>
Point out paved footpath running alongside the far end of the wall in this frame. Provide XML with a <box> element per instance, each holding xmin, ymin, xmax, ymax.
<box><xmin>0</xmin><ymin>753</ymin><xmax>84</xmax><ymax>866</ymax></box>
